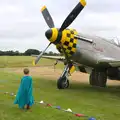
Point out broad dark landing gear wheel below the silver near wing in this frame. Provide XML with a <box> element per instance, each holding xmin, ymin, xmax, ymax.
<box><xmin>89</xmin><ymin>70</ymin><xmax>107</xmax><ymax>87</ymax></box>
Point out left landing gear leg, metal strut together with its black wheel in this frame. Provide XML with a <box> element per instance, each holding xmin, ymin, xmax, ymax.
<box><xmin>57</xmin><ymin>65</ymin><xmax>69</xmax><ymax>89</ymax></box>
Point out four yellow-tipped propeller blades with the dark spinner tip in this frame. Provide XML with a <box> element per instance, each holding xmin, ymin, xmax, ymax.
<box><xmin>35</xmin><ymin>0</ymin><xmax>86</xmax><ymax>64</ymax></box>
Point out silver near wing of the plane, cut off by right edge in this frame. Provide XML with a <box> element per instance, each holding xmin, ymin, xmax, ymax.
<box><xmin>98</xmin><ymin>57</ymin><xmax>120</xmax><ymax>67</ymax></box>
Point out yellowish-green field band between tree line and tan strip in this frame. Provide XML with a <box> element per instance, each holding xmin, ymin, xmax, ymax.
<box><xmin>0</xmin><ymin>56</ymin><xmax>63</xmax><ymax>69</ymax></box>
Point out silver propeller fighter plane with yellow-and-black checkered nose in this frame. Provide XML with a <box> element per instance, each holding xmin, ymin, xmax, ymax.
<box><xmin>33</xmin><ymin>0</ymin><xmax>120</xmax><ymax>89</ymax></box>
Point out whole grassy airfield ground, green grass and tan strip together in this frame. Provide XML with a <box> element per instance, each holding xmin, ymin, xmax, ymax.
<box><xmin>0</xmin><ymin>57</ymin><xmax>120</xmax><ymax>120</ymax></box>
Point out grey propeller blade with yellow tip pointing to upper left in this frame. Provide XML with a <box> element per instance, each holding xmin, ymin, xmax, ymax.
<box><xmin>41</xmin><ymin>6</ymin><xmax>54</xmax><ymax>28</ymax></box>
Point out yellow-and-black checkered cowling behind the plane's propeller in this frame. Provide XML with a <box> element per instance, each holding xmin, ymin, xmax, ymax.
<box><xmin>56</xmin><ymin>29</ymin><xmax>78</xmax><ymax>57</ymax></box>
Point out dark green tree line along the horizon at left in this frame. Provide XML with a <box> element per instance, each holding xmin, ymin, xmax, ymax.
<box><xmin>0</xmin><ymin>49</ymin><xmax>61</xmax><ymax>56</ymax></box>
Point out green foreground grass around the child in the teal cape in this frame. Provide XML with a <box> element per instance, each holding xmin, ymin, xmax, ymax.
<box><xmin>0</xmin><ymin>57</ymin><xmax>120</xmax><ymax>120</ymax></box>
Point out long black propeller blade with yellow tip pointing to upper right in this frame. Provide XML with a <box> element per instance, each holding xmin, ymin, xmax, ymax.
<box><xmin>59</xmin><ymin>0</ymin><xmax>86</xmax><ymax>31</ymax></box>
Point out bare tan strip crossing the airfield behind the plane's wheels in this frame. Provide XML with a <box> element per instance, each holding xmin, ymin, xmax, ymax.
<box><xmin>7</xmin><ymin>66</ymin><xmax>120</xmax><ymax>86</ymax></box>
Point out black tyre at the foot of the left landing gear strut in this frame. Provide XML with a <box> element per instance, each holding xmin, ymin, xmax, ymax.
<box><xmin>57</xmin><ymin>76</ymin><xmax>69</xmax><ymax>89</ymax></box>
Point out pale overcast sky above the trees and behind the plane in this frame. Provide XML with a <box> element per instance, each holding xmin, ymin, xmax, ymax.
<box><xmin>0</xmin><ymin>0</ymin><xmax>120</xmax><ymax>52</ymax></box>
